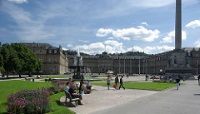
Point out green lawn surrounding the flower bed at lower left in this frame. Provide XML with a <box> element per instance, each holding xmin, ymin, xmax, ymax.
<box><xmin>0</xmin><ymin>81</ymin><xmax>73</xmax><ymax>114</ymax></box>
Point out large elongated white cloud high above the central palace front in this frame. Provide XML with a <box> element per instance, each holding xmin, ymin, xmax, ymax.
<box><xmin>96</xmin><ymin>26</ymin><xmax>160</xmax><ymax>42</ymax></box>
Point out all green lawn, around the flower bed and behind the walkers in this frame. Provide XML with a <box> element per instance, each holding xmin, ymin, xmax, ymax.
<box><xmin>0</xmin><ymin>81</ymin><xmax>175</xmax><ymax>114</ymax></box>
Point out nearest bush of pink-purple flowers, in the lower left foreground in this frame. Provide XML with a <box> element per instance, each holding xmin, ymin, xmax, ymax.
<box><xmin>7</xmin><ymin>89</ymin><xmax>50</xmax><ymax>114</ymax></box>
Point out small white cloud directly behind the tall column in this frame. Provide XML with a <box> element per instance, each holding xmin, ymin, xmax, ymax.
<box><xmin>160</xmin><ymin>31</ymin><xmax>187</xmax><ymax>43</ymax></box>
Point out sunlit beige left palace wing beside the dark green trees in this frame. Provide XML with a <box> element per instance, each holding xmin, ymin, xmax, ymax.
<box><xmin>23</xmin><ymin>43</ymin><xmax>69</xmax><ymax>74</ymax></box>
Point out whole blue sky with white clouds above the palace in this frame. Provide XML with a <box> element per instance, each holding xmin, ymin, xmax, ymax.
<box><xmin>0</xmin><ymin>0</ymin><xmax>200</xmax><ymax>54</ymax></box>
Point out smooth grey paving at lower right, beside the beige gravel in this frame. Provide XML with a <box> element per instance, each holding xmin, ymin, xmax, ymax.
<box><xmin>91</xmin><ymin>80</ymin><xmax>200</xmax><ymax>114</ymax></box>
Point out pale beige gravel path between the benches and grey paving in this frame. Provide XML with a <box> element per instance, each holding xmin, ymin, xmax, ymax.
<box><xmin>69</xmin><ymin>77</ymin><xmax>157</xmax><ymax>114</ymax></box>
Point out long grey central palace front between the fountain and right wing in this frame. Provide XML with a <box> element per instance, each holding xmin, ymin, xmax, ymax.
<box><xmin>69</xmin><ymin>54</ymin><xmax>144</xmax><ymax>74</ymax></box>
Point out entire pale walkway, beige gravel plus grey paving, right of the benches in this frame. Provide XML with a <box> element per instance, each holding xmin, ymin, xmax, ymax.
<box><xmin>69</xmin><ymin>76</ymin><xmax>200</xmax><ymax>114</ymax></box>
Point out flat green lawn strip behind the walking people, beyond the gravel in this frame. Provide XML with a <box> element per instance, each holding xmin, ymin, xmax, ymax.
<box><xmin>92</xmin><ymin>81</ymin><xmax>175</xmax><ymax>91</ymax></box>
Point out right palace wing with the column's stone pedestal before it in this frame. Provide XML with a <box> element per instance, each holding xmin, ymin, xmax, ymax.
<box><xmin>142</xmin><ymin>48</ymin><xmax>200</xmax><ymax>75</ymax></box>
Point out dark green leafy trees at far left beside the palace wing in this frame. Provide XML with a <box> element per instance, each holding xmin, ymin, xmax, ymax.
<box><xmin>0</xmin><ymin>43</ymin><xmax>42</xmax><ymax>77</ymax></box>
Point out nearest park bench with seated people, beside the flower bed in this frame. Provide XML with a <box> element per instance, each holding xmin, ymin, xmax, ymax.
<box><xmin>60</xmin><ymin>91</ymin><xmax>80</xmax><ymax>107</ymax></box>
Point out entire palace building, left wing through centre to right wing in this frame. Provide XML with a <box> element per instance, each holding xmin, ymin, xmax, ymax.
<box><xmin>24</xmin><ymin>43</ymin><xmax>200</xmax><ymax>75</ymax></box>
